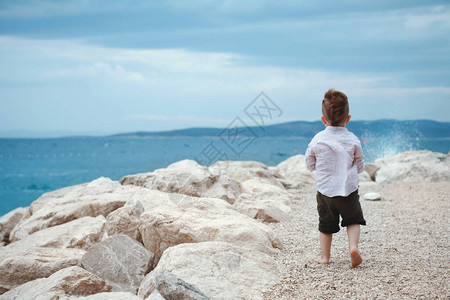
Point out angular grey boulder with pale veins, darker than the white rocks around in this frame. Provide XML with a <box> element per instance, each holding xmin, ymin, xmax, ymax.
<box><xmin>81</xmin><ymin>235</ymin><xmax>154</xmax><ymax>294</ymax></box>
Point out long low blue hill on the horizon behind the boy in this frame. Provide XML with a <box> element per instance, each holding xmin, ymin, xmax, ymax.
<box><xmin>110</xmin><ymin>120</ymin><xmax>450</xmax><ymax>139</ymax></box>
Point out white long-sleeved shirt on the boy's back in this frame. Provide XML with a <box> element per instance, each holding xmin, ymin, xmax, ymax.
<box><xmin>305</xmin><ymin>126</ymin><xmax>364</xmax><ymax>197</ymax></box>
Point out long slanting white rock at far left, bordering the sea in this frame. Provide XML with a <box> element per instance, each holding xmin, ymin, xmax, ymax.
<box><xmin>10</xmin><ymin>177</ymin><xmax>128</xmax><ymax>241</ymax></box>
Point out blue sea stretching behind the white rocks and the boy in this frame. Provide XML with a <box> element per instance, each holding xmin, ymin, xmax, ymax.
<box><xmin>0</xmin><ymin>135</ymin><xmax>450</xmax><ymax>215</ymax></box>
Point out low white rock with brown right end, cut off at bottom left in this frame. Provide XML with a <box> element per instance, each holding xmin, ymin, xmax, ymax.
<box><xmin>0</xmin><ymin>266</ymin><xmax>112</xmax><ymax>300</ymax></box>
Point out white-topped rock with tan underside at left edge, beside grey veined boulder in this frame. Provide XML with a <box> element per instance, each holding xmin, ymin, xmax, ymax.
<box><xmin>0</xmin><ymin>247</ymin><xmax>85</xmax><ymax>294</ymax></box>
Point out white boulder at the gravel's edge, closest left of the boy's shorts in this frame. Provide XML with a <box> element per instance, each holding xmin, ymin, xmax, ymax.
<box><xmin>233</xmin><ymin>179</ymin><xmax>291</xmax><ymax>222</ymax></box>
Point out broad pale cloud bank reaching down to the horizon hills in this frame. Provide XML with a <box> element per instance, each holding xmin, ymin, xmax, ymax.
<box><xmin>0</xmin><ymin>36</ymin><xmax>449</xmax><ymax>132</ymax></box>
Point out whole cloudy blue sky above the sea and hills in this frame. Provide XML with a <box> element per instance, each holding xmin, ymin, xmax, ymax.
<box><xmin>0</xmin><ymin>0</ymin><xmax>450</xmax><ymax>136</ymax></box>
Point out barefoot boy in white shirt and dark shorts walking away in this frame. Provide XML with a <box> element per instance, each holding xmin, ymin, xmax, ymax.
<box><xmin>305</xmin><ymin>89</ymin><xmax>366</xmax><ymax>267</ymax></box>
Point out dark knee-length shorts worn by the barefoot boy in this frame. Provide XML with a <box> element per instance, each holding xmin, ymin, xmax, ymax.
<box><xmin>316</xmin><ymin>190</ymin><xmax>366</xmax><ymax>233</ymax></box>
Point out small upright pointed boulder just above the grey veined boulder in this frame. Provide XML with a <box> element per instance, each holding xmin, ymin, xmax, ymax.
<box><xmin>106</xmin><ymin>200</ymin><xmax>144</xmax><ymax>242</ymax></box>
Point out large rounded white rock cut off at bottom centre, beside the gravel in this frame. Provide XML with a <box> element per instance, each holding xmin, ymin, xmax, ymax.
<box><xmin>138</xmin><ymin>242</ymin><xmax>280</xmax><ymax>300</ymax></box>
